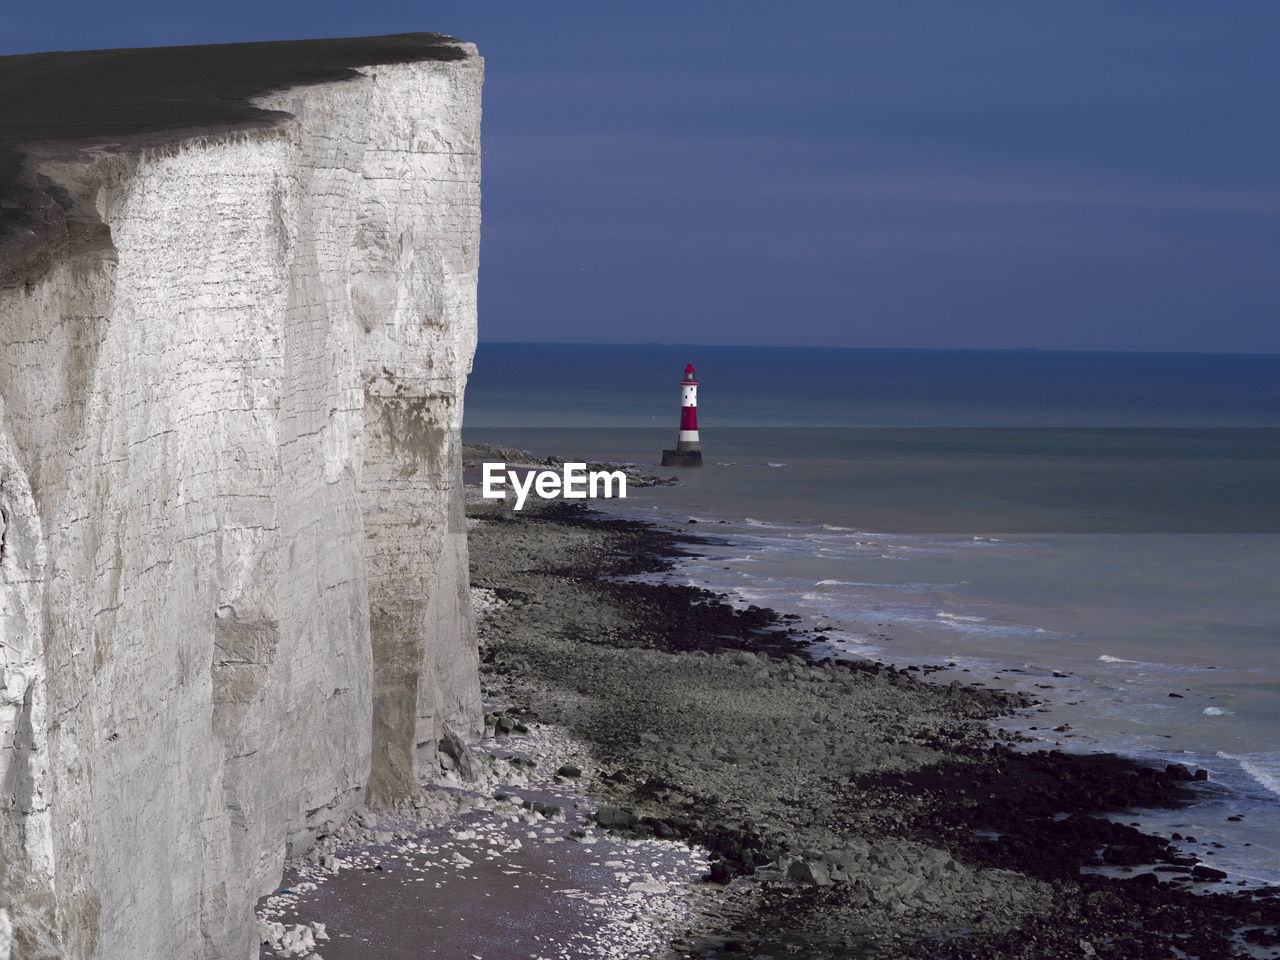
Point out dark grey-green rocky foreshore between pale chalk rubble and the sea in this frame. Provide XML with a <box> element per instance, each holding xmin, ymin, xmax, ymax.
<box><xmin>264</xmin><ymin>491</ymin><xmax>1280</xmax><ymax>960</ymax></box>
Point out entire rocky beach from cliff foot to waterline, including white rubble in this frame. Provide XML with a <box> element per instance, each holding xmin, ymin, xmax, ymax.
<box><xmin>254</xmin><ymin>481</ymin><xmax>1280</xmax><ymax>960</ymax></box>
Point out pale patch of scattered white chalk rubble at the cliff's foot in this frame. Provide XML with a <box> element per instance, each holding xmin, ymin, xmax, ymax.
<box><xmin>259</xmin><ymin>713</ymin><xmax>732</xmax><ymax>960</ymax></box>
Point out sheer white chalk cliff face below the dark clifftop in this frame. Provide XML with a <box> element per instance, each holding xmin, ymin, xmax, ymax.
<box><xmin>0</xmin><ymin>33</ymin><xmax>483</xmax><ymax>959</ymax></box>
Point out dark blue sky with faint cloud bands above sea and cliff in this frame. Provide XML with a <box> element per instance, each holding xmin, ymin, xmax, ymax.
<box><xmin>0</xmin><ymin>0</ymin><xmax>1280</xmax><ymax>352</ymax></box>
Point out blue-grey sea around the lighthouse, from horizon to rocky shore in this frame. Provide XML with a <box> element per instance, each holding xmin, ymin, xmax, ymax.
<box><xmin>463</xmin><ymin>343</ymin><xmax>1280</xmax><ymax>886</ymax></box>
